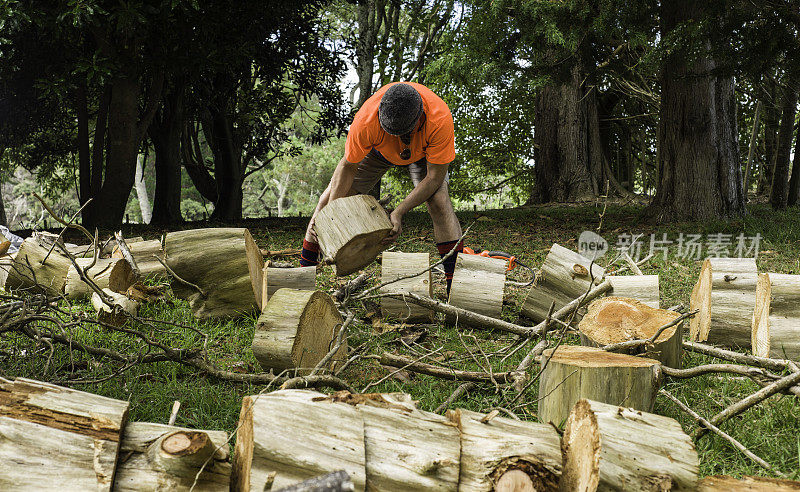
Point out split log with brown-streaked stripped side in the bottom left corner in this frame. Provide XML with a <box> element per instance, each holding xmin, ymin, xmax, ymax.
<box><xmin>0</xmin><ymin>378</ymin><xmax>128</xmax><ymax>491</ymax></box>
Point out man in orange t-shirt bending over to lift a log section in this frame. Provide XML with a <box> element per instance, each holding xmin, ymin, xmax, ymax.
<box><xmin>300</xmin><ymin>82</ymin><xmax>463</xmax><ymax>292</ymax></box>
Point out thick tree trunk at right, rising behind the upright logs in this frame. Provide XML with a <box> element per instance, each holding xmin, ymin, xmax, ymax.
<box><xmin>648</xmin><ymin>0</ymin><xmax>745</xmax><ymax>221</ymax></box>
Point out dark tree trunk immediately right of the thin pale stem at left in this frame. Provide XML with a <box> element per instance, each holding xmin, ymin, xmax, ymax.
<box><xmin>149</xmin><ymin>87</ymin><xmax>184</xmax><ymax>224</ymax></box>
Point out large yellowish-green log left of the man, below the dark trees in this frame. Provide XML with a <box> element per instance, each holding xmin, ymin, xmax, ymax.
<box><xmin>164</xmin><ymin>228</ymin><xmax>264</xmax><ymax>318</ymax></box>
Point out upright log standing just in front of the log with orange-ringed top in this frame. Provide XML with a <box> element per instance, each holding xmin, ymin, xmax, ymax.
<box><xmin>539</xmin><ymin>345</ymin><xmax>659</xmax><ymax>425</ymax></box>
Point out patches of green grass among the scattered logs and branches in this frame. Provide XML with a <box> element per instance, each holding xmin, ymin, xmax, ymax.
<box><xmin>0</xmin><ymin>205</ymin><xmax>800</xmax><ymax>478</ymax></box>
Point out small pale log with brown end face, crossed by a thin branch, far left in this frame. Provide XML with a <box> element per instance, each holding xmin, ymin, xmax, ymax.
<box><xmin>64</xmin><ymin>258</ymin><xmax>136</xmax><ymax>299</ymax></box>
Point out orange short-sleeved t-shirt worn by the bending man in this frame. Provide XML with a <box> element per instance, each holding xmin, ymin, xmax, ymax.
<box><xmin>344</xmin><ymin>82</ymin><xmax>456</xmax><ymax>166</ymax></box>
